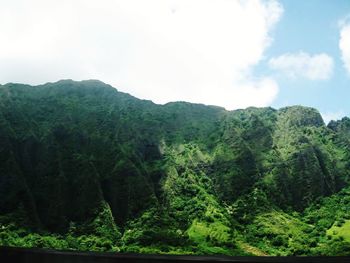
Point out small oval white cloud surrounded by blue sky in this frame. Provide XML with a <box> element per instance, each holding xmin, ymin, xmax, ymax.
<box><xmin>269</xmin><ymin>52</ymin><xmax>334</xmax><ymax>80</ymax></box>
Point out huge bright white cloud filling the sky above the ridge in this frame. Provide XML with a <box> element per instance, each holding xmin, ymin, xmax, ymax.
<box><xmin>0</xmin><ymin>0</ymin><xmax>283</xmax><ymax>109</ymax></box>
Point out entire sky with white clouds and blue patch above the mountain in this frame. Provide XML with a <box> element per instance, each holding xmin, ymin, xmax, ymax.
<box><xmin>0</xmin><ymin>0</ymin><xmax>350</xmax><ymax>122</ymax></box>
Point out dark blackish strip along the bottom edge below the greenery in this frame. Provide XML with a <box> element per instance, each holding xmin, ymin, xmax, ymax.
<box><xmin>0</xmin><ymin>247</ymin><xmax>350</xmax><ymax>263</ymax></box>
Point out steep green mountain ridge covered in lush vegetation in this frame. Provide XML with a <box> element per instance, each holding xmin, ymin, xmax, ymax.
<box><xmin>0</xmin><ymin>80</ymin><xmax>350</xmax><ymax>255</ymax></box>
